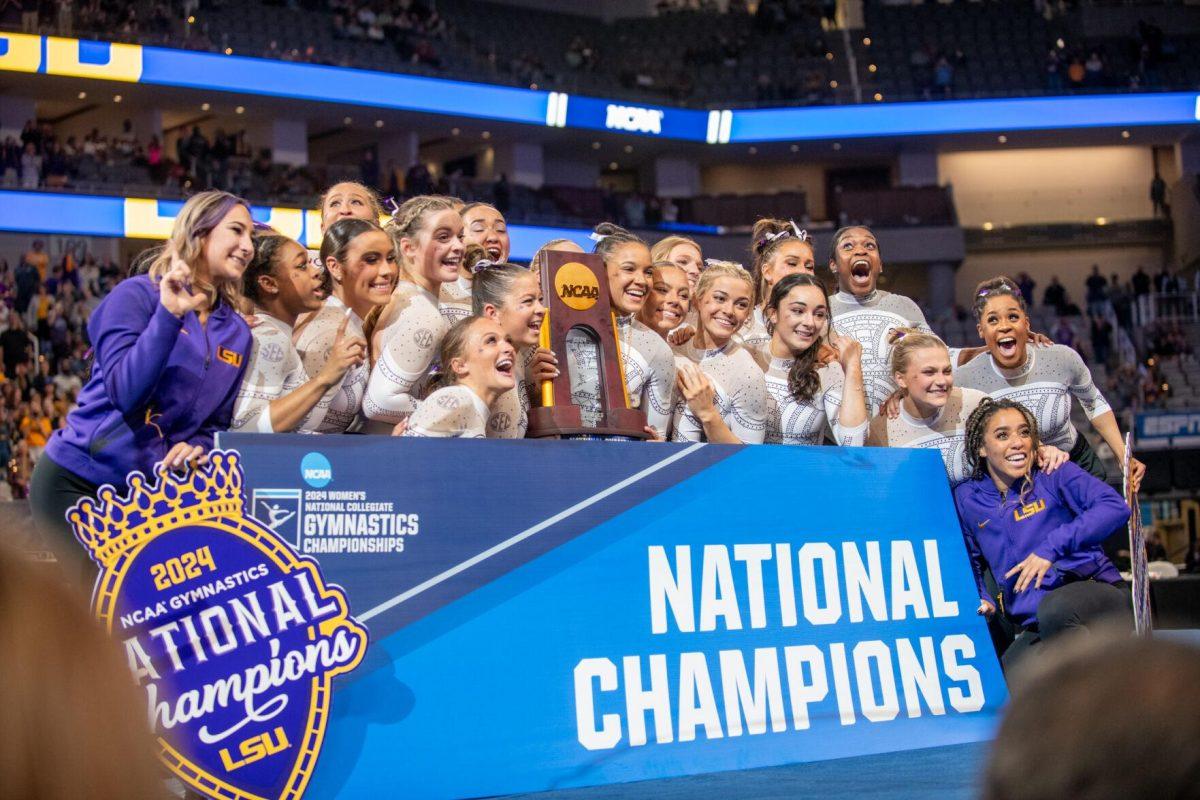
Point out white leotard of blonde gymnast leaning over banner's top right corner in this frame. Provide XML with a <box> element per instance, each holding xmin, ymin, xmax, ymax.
<box><xmin>866</xmin><ymin>386</ymin><xmax>986</xmax><ymax>486</ymax></box>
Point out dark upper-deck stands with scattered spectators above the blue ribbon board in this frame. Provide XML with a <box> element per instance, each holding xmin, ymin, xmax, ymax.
<box><xmin>0</xmin><ymin>0</ymin><xmax>1200</xmax><ymax>106</ymax></box>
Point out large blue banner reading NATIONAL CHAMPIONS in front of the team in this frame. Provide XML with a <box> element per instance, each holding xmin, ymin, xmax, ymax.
<box><xmin>211</xmin><ymin>434</ymin><xmax>1007</xmax><ymax>798</ymax></box>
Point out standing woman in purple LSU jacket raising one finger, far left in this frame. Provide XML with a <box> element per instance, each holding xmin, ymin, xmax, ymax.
<box><xmin>30</xmin><ymin>192</ymin><xmax>254</xmax><ymax>576</ymax></box>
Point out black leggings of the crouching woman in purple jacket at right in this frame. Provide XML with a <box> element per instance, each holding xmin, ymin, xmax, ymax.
<box><xmin>1001</xmin><ymin>581</ymin><xmax>1133</xmax><ymax>673</ymax></box>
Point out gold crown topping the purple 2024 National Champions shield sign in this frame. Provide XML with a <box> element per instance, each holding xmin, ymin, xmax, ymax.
<box><xmin>67</xmin><ymin>450</ymin><xmax>244</xmax><ymax>569</ymax></box>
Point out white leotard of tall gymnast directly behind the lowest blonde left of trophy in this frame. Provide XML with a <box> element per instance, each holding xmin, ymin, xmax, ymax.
<box><xmin>362</xmin><ymin>281</ymin><xmax>450</xmax><ymax>433</ymax></box>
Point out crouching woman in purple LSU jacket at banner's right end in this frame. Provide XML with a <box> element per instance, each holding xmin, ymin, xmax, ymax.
<box><xmin>954</xmin><ymin>398</ymin><xmax>1132</xmax><ymax>669</ymax></box>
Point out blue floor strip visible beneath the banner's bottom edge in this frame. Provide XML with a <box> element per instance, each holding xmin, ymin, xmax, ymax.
<box><xmin>506</xmin><ymin>744</ymin><xmax>988</xmax><ymax>800</ymax></box>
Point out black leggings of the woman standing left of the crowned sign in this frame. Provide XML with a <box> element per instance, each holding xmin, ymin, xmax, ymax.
<box><xmin>29</xmin><ymin>453</ymin><xmax>100</xmax><ymax>591</ymax></box>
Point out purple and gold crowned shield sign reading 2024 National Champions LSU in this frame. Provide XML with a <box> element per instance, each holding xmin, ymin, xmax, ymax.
<box><xmin>67</xmin><ymin>451</ymin><xmax>367</xmax><ymax>800</ymax></box>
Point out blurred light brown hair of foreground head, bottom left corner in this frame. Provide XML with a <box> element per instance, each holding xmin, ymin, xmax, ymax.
<box><xmin>0</xmin><ymin>541</ymin><xmax>166</xmax><ymax>800</ymax></box>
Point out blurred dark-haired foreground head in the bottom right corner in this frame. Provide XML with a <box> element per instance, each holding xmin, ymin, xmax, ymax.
<box><xmin>983</xmin><ymin>634</ymin><xmax>1200</xmax><ymax>800</ymax></box>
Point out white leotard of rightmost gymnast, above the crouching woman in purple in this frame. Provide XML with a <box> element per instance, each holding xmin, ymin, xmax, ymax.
<box><xmin>954</xmin><ymin>344</ymin><xmax>1112</xmax><ymax>452</ymax></box>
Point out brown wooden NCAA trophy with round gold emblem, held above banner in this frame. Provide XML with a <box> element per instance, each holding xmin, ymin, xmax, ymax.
<box><xmin>528</xmin><ymin>251</ymin><xmax>647</xmax><ymax>439</ymax></box>
